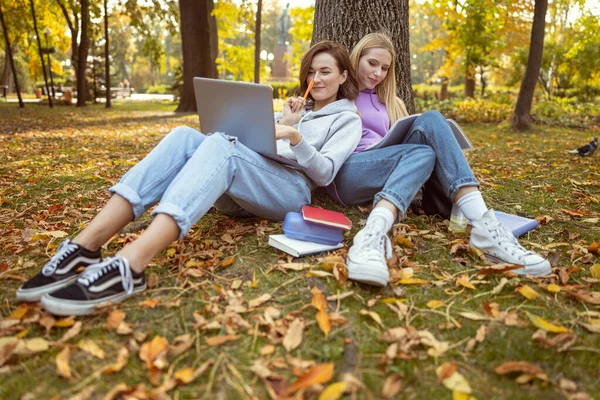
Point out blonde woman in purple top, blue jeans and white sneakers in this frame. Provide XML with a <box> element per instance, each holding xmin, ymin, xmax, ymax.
<box><xmin>328</xmin><ymin>33</ymin><xmax>550</xmax><ymax>286</ymax></box>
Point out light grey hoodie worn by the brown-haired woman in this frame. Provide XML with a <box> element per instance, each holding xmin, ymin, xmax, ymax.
<box><xmin>275</xmin><ymin>99</ymin><xmax>362</xmax><ymax>190</ymax></box>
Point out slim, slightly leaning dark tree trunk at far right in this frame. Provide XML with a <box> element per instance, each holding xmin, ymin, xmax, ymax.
<box><xmin>512</xmin><ymin>0</ymin><xmax>548</xmax><ymax>131</ymax></box>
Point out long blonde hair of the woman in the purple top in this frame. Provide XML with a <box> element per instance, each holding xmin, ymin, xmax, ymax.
<box><xmin>350</xmin><ymin>32</ymin><xmax>408</xmax><ymax>126</ymax></box>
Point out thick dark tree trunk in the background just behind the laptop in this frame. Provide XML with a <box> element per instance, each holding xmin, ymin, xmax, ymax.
<box><xmin>176</xmin><ymin>0</ymin><xmax>218</xmax><ymax>112</ymax></box>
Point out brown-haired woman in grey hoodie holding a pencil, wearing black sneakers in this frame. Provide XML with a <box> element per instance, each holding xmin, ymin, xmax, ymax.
<box><xmin>17</xmin><ymin>41</ymin><xmax>361</xmax><ymax>315</ymax></box>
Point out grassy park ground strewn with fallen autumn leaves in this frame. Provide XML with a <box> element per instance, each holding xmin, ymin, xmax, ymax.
<box><xmin>0</xmin><ymin>102</ymin><xmax>600</xmax><ymax>399</ymax></box>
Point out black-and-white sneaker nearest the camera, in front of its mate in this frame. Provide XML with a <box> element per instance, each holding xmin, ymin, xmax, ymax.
<box><xmin>42</xmin><ymin>256</ymin><xmax>146</xmax><ymax>316</ymax></box>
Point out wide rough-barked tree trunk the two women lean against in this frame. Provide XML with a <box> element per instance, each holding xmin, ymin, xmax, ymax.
<box><xmin>312</xmin><ymin>0</ymin><xmax>415</xmax><ymax>114</ymax></box>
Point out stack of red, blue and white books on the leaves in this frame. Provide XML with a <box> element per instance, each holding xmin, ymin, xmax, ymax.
<box><xmin>269</xmin><ymin>206</ymin><xmax>352</xmax><ymax>257</ymax></box>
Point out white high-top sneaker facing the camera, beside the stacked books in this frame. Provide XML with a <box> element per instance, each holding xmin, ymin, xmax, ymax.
<box><xmin>346</xmin><ymin>224</ymin><xmax>392</xmax><ymax>286</ymax></box>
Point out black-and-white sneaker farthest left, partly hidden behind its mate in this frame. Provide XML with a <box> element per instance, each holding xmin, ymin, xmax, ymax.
<box><xmin>17</xmin><ymin>239</ymin><xmax>102</xmax><ymax>302</ymax></box>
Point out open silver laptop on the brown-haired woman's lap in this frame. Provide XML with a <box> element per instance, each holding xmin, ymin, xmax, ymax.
<box><xmin>194</xmin><ymin>78</ymin><xmax>300</xmax><ymax>167</ymax></box>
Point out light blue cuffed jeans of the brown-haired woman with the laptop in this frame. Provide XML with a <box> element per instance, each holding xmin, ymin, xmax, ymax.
<box><xmin>110</xmin><ymin>126</ymin><xmax>311</xmax><ymax>238</ymax></box>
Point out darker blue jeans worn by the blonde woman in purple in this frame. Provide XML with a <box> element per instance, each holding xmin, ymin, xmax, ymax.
<box><xmin>328</xmin><ymin>111</ymin><xmax>479</xmax><ymax>217</ymax></box>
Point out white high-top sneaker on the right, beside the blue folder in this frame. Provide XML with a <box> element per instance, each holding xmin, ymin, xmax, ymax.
<box><xmin>470</xmin><ymin>210</ymin><xmax>552</xmax><ymax>276</ymax></box>
